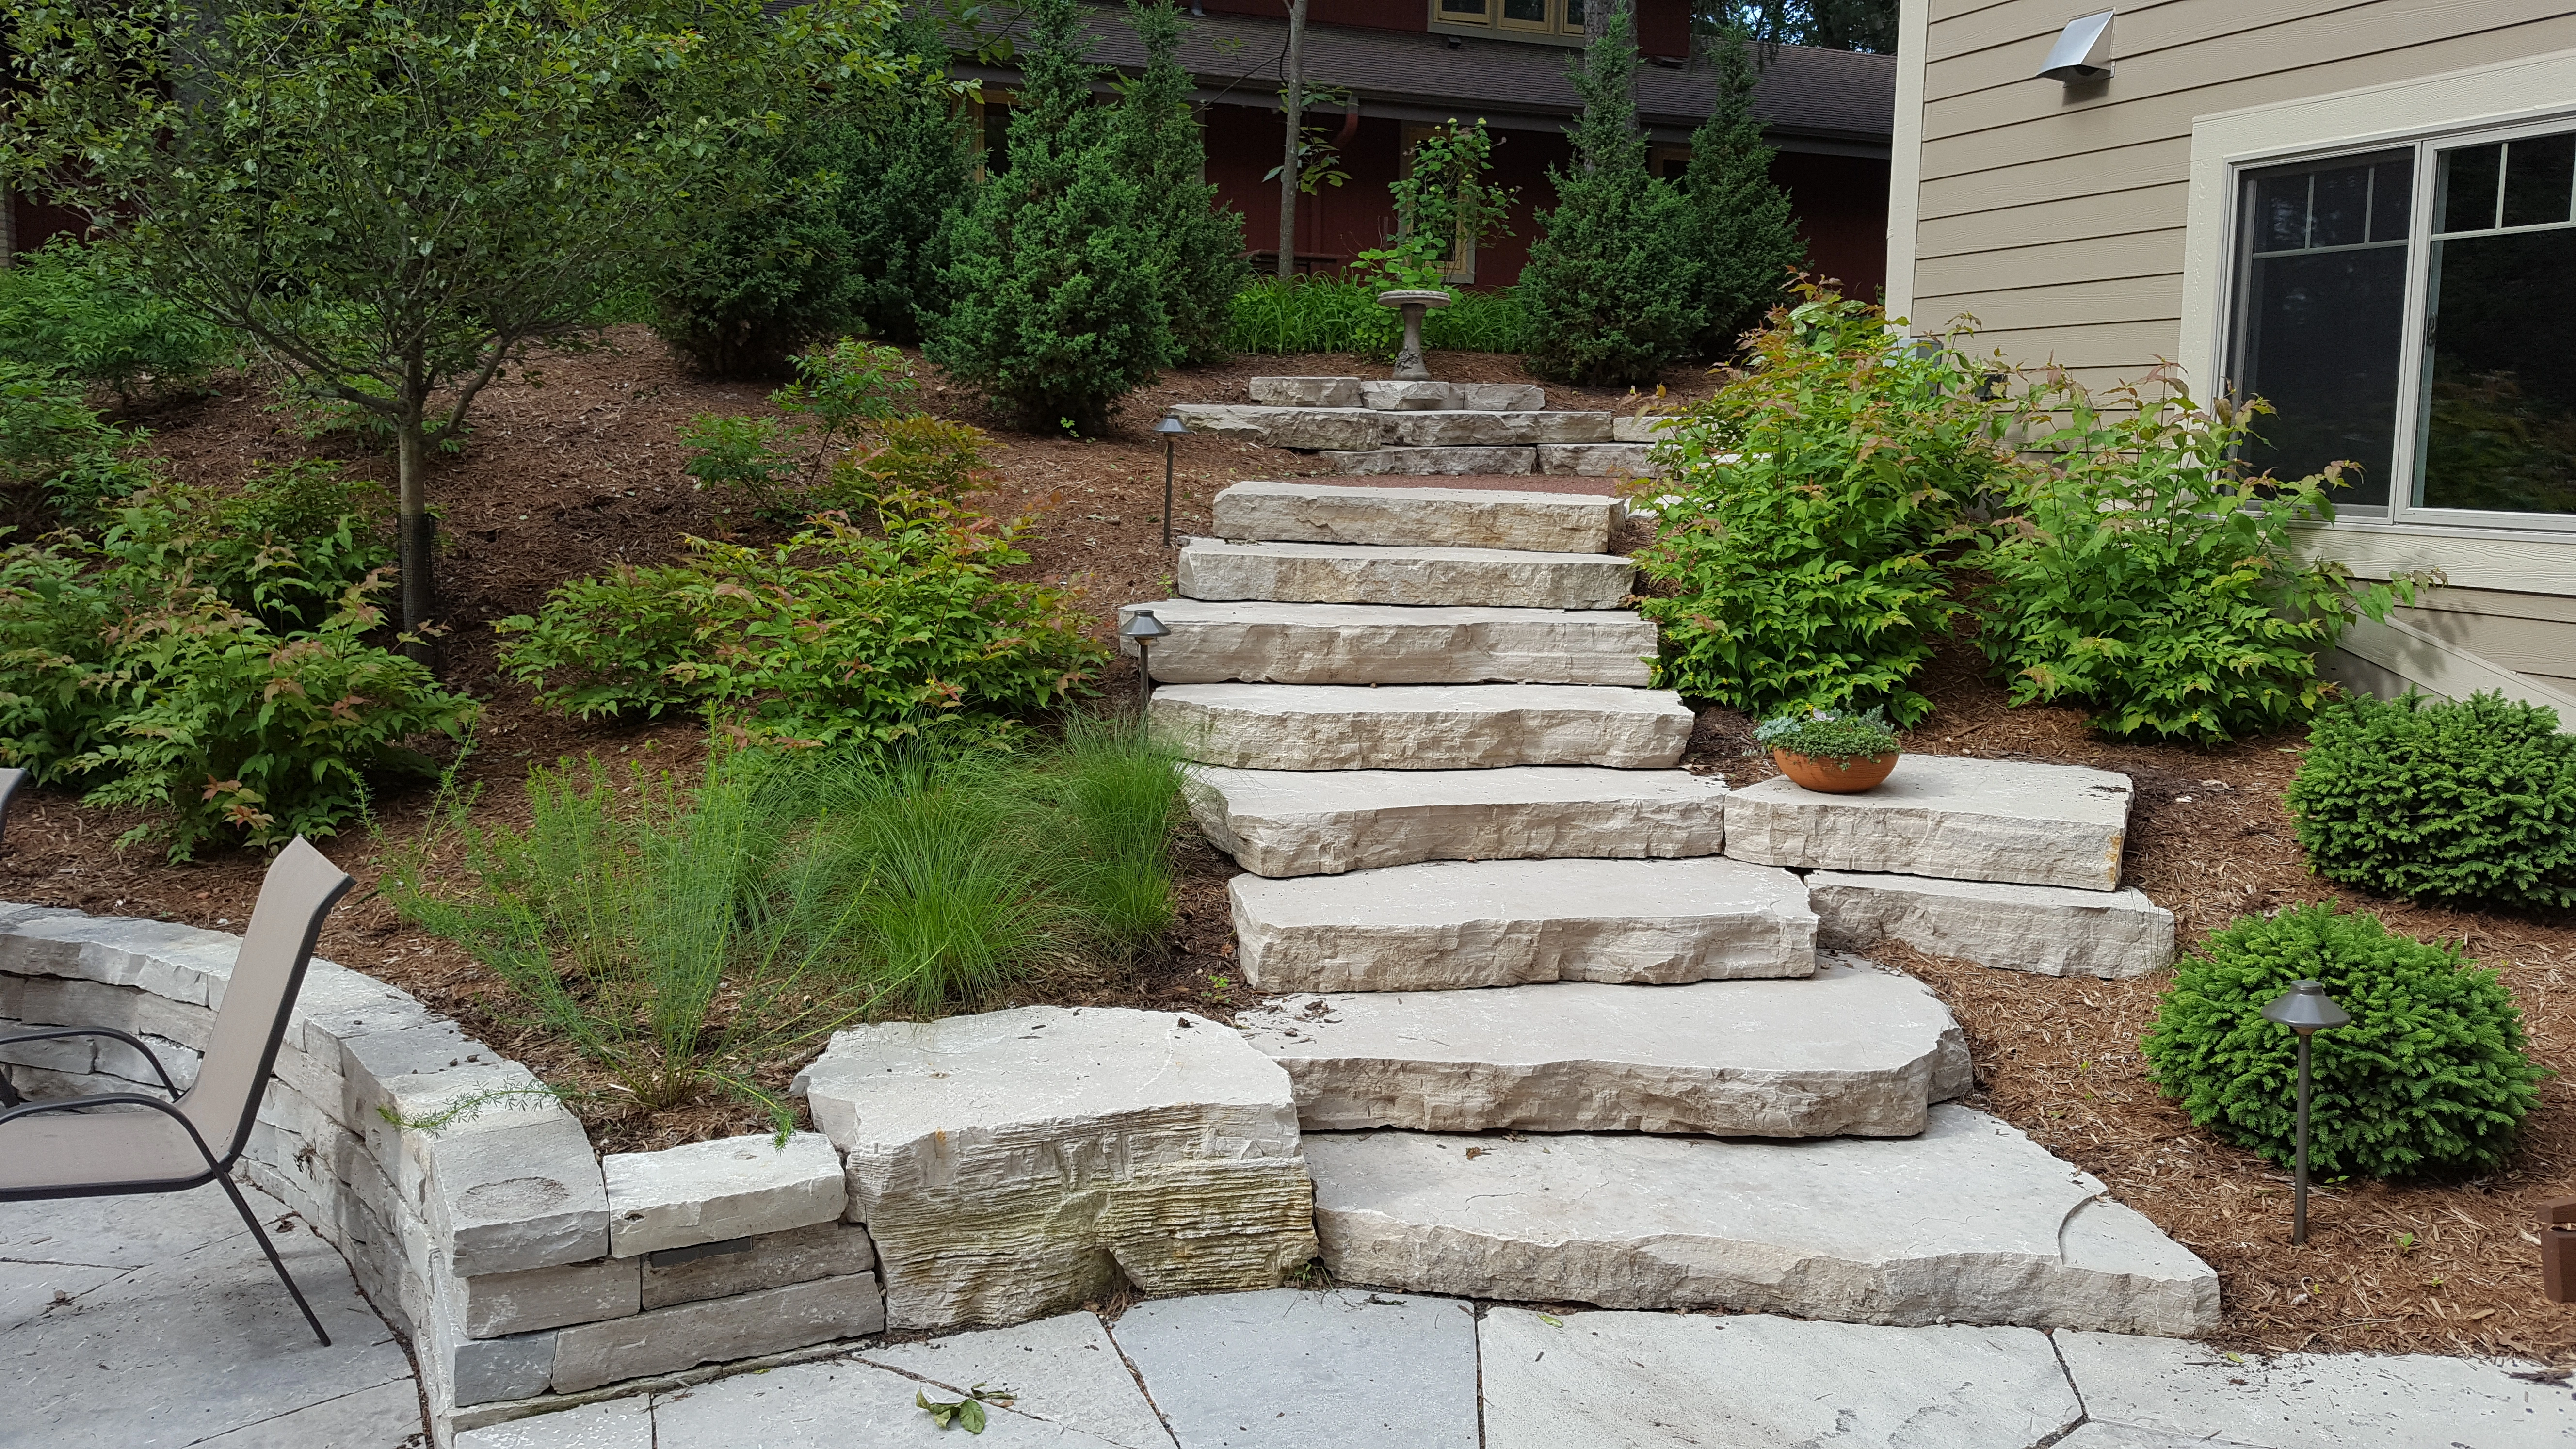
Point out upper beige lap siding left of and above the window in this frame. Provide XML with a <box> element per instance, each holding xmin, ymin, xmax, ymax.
<box><xmin>1912</xmin><ymin>0</ymin><xmax>2576</xmax><ymax>379</ymax></box>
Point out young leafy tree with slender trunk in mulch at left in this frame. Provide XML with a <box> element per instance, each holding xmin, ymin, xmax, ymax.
<box><xmin>0</xmin><ymin>0</ymin><xmax>891</xmax><ymax>652</ymax></box>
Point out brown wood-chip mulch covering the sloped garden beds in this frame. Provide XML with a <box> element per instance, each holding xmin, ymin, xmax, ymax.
<box><xmin>0</xmin><ymin>327</ymin><xmax>2576</xmax><ymax>1364</ymax></box>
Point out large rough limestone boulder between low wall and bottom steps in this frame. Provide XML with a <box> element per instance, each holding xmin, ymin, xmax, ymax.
<box><xmin>804</xmin><ymin>1006</ymin><xmax>1314</xmax><ymax>1328</ymax></box>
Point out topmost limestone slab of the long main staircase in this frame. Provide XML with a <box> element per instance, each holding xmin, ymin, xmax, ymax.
<box><xmin>1213</xmin><ymin>482</ymin><xmax>1620</xmax><ymax>554</ymax></box>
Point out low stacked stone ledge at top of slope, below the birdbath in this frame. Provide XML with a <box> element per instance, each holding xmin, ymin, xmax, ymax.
<box><xmin>1175</xmin><ymin>376</ymin><xmax>1654</xmax><ymax>479</ymax></box>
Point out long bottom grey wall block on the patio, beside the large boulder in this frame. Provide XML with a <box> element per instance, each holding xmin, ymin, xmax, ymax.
<box><xmin>554</xmin><ymin>1273</ymin><xmax>886</xmax><ymax>1395</ymax></box>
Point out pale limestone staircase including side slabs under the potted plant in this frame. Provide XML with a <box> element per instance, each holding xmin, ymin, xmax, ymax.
<box><xmin>1133</xmin><ymin>471</ymin><xmax>2218</xmax><ymax>1333</ymax></box>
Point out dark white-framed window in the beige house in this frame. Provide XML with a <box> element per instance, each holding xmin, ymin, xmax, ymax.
<box><xmin>2226</xmin><ymin>121</ymin><xmax>2576</xmax><ymax>529</ymax></box>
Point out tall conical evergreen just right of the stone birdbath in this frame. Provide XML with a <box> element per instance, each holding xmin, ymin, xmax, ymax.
<box><xmin>1520</xmin><ymin>5</ymin><xmax>1708</xmax><ymax>387</ymax></box>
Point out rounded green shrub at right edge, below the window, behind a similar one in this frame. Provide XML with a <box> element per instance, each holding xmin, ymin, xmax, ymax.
<box><xmin>2287</xmin><ymin>693</ymin><xmax>2576</xmax><ymax>907</ymax></box>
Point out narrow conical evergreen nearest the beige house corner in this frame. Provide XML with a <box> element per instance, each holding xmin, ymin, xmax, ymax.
<box><xmin>1672</xmin><ymin>31</ymin><xmax>1806</xmax><ymax>358</ymax></box>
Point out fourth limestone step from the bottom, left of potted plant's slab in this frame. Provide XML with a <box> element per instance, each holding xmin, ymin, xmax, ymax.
<box><xmin>1182</xmin><ymin>766</ymin><xmax>1726</xmax><ymax>877</ymax></box>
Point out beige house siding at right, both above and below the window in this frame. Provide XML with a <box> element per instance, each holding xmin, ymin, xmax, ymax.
<box><xmin>1888</xmin><ymin>0</ymin><xmax>2576</xmax><ymax>711</ymax></box>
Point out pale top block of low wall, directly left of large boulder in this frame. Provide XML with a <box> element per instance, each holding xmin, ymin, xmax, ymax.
<box><xmin>600</xmin><ymin>1132</ymin><xmax>848</xmax><ymax>1258</ymax></box>
